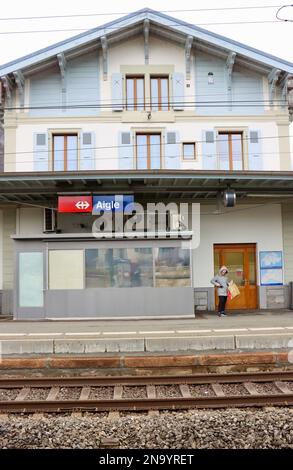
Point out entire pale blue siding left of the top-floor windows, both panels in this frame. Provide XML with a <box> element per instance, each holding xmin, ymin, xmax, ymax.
<box><xmin>29</xmin><ymin>52</ymin><xmax>100</xmax><ymax>116</ymax></box>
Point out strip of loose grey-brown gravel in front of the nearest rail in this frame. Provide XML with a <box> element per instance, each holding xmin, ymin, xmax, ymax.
<box><xmin>0</xmin><ymin>407</ymin><xmax>293</xmax><ymax>449</ymax></box>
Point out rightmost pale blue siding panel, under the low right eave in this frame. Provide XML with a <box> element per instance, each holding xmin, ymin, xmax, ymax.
<box><xmin>232</xmin><ymin>69</ymin><xmax>264</xmax><ymax>114</ymax></box>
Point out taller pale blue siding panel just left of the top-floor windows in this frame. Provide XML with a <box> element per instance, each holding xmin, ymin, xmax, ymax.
<box><xmin>66</xmin><ymin>52</ymin><xmax>101</xmax><ymax>116</ymax></box>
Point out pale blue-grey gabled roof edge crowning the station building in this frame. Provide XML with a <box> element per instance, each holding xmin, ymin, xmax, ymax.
<box><xmin>0</xmin><ymin>8</ymin><xmax>293</xmax><ymax>76</ymax></box>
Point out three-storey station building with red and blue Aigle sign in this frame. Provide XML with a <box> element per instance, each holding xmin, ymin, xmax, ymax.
<box><xmin>0</xmin><ymin>9</ymin><xmax>293</xmax><ymax>319</ymax></box>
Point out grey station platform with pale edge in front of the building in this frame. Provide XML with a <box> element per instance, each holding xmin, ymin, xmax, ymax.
<box><xmin>0</xmin><ymin>310</ymin><xmax>293</xmax><ymax>355</ymax></box>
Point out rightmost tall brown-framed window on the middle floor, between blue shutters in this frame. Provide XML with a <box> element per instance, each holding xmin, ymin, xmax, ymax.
<box><xmin>218</xmin><ymin>132</ymin><xmax>243</xmax><ymax>171</ymax></box>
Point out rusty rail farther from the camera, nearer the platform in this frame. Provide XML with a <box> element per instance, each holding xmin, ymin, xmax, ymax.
<box><xmin>0</xmin><ymin>370</ymin><xmax>293</xmax><ymax>389</ymax></box>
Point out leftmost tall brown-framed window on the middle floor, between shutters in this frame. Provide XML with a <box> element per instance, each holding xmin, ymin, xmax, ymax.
<box><xmin>53</xmin><ymin>134</ymin><xmax>78</xmax><ymax>171</ymax></box>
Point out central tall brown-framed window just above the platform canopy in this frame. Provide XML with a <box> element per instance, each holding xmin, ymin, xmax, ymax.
<box><xmin>136</xmin><ymin>134</ymin><xmax>161</xmax><ymax>170</ymax></box>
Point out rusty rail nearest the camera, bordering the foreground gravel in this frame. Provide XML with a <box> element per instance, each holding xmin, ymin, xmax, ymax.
<box><xmin>0</xmin><ymin>394</ymin><xmax>293</xmax><ymax>413</ymax></box>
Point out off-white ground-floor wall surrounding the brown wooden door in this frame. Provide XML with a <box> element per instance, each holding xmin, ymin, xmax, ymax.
<box><xmin>193</xmin><ymin>204</ymin><xmax>283</xmax><ymax>287</ymax></box>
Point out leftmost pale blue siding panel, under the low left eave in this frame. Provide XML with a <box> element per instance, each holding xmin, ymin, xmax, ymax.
<box><xmin>29</xmin><ymin>71</ymin><xmax>62</xmax><ymax>116</ymax></box>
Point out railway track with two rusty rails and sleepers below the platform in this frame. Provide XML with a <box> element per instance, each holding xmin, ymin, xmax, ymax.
<box><xmin>0</xmin><ymin>371</ymin><xmax>293</xmax><ymax>413</ymax></box>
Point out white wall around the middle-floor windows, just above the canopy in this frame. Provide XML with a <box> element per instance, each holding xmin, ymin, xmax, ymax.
<box><xmin>16</xmin><ymin>117</ymin><xmax>280</xmax><ymax>171</ymax></box>
